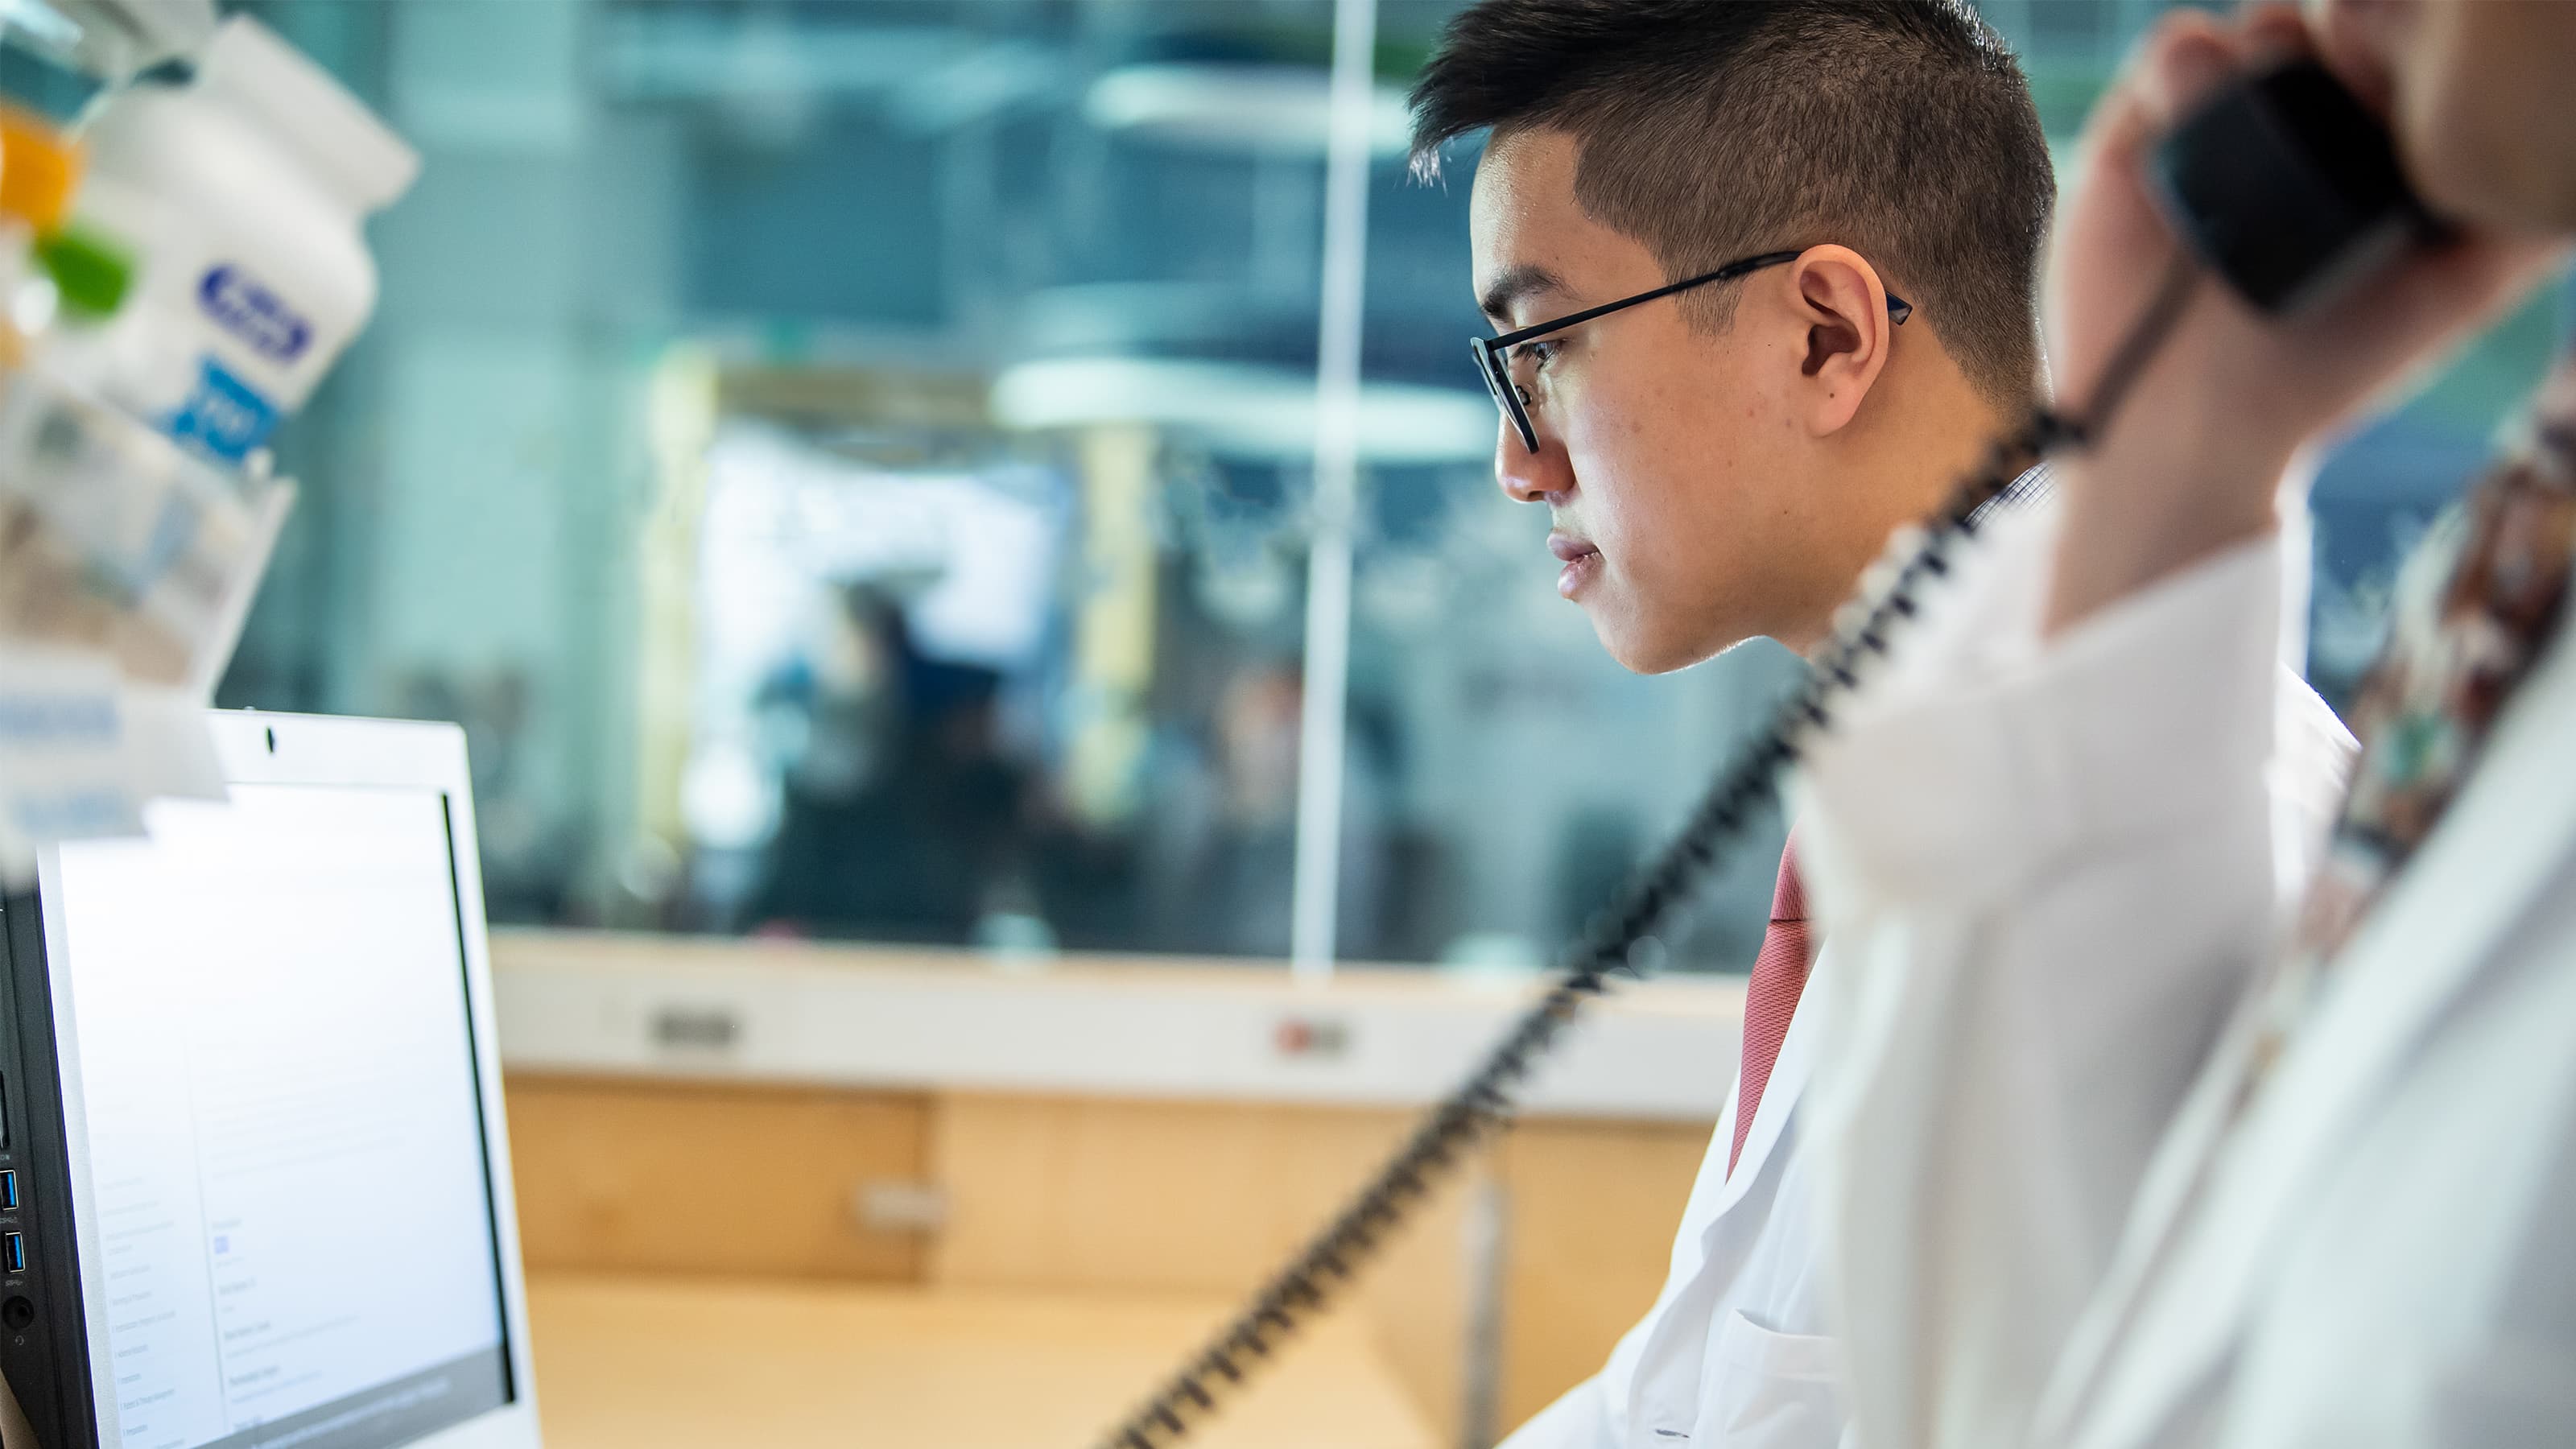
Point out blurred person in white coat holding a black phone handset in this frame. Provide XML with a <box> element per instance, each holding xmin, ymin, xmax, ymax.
<box><xmin>1803</xmin><ymin>0</ymin><xmax>2576</xmax><ymax>1449</ymax></box>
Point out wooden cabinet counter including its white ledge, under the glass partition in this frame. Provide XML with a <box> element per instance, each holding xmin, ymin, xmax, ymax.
<box><xmin>492</xmin><ymin>931</ymin><xmax>1744</xmax><ymax>1449</ymax></box>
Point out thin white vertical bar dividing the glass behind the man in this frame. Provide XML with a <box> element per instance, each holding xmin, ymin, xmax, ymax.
<box><xmin>1288</xmin><ymin>0</ymin><xmax>1378</xmax><ymax>982</ymax></box>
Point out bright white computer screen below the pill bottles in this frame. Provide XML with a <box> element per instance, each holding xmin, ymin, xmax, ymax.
<box><xmin>47</xmin><ymin>784</ymin><xmax>513</xmax><ymax>1449</ymax></box>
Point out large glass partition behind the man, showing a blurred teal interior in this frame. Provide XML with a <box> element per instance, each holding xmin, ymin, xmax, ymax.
<box><xmin>221</xmin><ymin>0</ymin><xmax>2558</xmax><ymax>969</ymax></box>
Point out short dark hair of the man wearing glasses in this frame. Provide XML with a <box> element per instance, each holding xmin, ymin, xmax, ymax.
<box><xmin>1412</xmin><ymin>0</ymin><xmax>2058</xmax><ymax>405</ymax></box>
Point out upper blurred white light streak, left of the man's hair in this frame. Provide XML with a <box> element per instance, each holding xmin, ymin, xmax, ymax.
<box><xmin>1082</xmin><ymin>62</ymin><xmax>1412</xmax><ymax>157</ymax></box>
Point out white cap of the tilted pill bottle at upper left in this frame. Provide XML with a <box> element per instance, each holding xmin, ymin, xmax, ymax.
<box><xmin>196</xmin><ymin>15</ymin><xmax>420</xmax><ymax>212</ymax></box>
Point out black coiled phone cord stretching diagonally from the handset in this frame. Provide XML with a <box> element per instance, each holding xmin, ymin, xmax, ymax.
<box><xmin>1100</xmin><ymin>253</ymin><xmax>2200</xmax><ymax>1449</ymax></box>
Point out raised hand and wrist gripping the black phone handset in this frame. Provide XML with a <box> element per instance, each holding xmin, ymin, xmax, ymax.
<box><xmin>2046</xmin><ymin>5</ymin><xmax>2553</xmax><ymax>632</ymax></box>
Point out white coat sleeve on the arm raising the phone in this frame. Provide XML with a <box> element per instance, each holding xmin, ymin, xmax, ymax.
<box><xmin>1798</xmin><ymin>508</ymin><xmax>2349</xmax><ymax>1449</ymax></box>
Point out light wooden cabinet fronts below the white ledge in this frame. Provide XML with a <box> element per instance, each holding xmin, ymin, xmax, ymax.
<box><xmin>507</xmin><ymin>1072</ymin><xmax>1708</xmax><ymax>1444</ymax></box>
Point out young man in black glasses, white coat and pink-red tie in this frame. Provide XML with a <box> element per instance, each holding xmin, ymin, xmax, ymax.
<box><xmin>1414</xmin><ymin>0</ymin><xmax>2359</xmax><ymax>1449</ymax></box>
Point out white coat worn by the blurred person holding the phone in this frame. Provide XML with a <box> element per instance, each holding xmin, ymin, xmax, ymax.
<box><xmin>1803</xmin><ymin>481</ymin><xmax>2576</xmax><ymax>1449</ymax></box>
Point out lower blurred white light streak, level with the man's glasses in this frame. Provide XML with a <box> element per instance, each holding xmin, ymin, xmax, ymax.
<box><xmin>992</xmin><ymin>358</ymin><xmax>1494</xmax><ymax>464</ymax></box>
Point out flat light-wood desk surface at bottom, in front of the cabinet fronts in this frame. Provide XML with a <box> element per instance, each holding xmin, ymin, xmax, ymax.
<box><xmin>528</xmin><ymin>1274</ymin><xmax>1438</xmax><ymax>1449</ymax></box>
